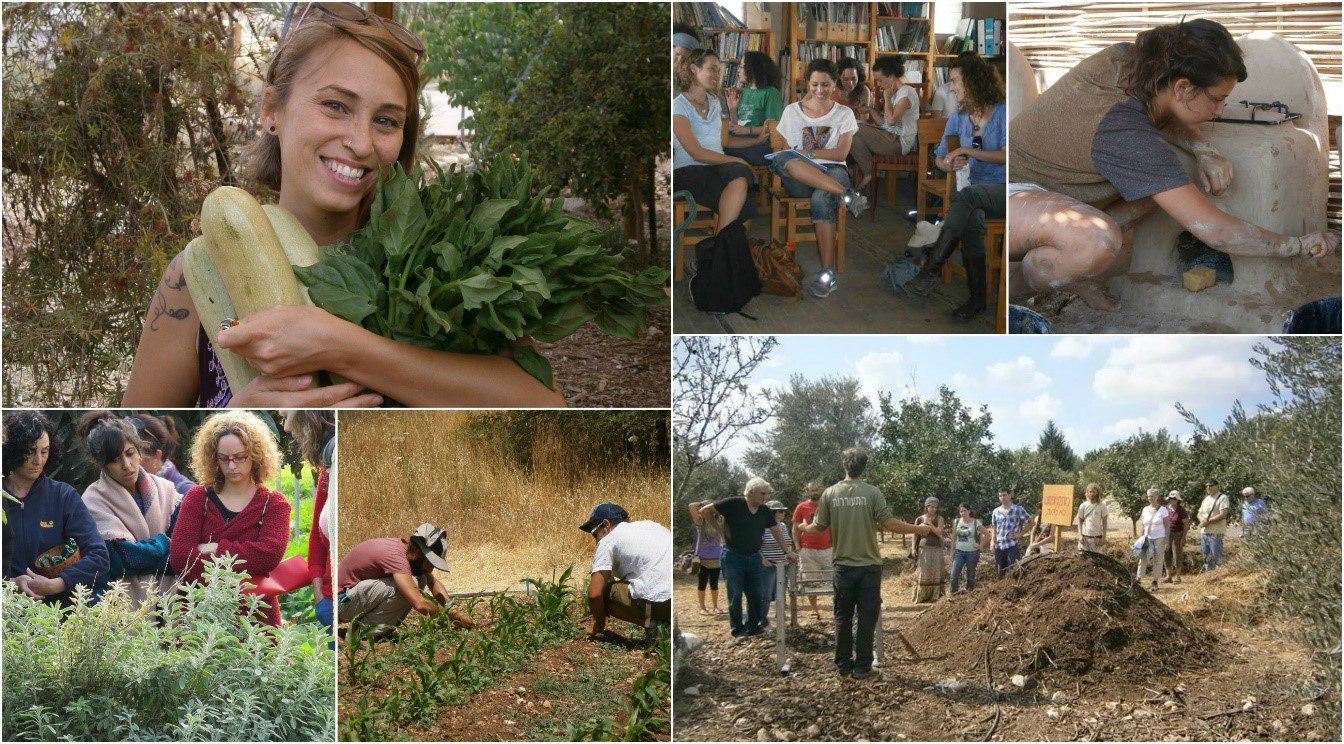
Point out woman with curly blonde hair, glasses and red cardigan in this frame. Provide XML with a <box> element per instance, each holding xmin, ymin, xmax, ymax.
<box><xmin>168</xmin><ymin>411</ymin><xmax>290</xmax><ymax>626</ymax></box>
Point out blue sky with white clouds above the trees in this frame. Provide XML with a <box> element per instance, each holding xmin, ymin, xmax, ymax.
<box><xmin>693</xmin><ymin>336</ymin><xmax>1271</xmax><ymax>467</ymax></box>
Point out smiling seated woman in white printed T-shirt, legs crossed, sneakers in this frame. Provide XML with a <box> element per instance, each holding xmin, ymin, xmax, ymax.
<box><xmin>770</xmin><ymin>59</ymin><xmax>868</xmax><ymax>298</ymax></box>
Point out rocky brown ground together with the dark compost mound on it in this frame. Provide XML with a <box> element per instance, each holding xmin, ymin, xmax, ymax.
<box><xmin>673</xmin><ymin>534</ymin><xmax>1340</xmax><ymax>741</ymax></box>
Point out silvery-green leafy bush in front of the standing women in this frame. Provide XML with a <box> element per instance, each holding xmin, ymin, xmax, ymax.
<box><xmin>3</xmin><ymin>560</ymin><xmax>336</xmax><ymax>741</ymax></box>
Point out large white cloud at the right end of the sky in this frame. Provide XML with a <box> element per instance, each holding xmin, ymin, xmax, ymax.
<box><xmin>1093</xmin><ymin>336</ymin><xmax>1263</xmax><ymax>403</ymax></box>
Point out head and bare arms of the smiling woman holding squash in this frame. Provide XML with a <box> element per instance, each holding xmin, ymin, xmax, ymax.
<box><xmin>122</xmin><ymin>3</ymin><xmax>563</xmax><ymax>408</ymax></box>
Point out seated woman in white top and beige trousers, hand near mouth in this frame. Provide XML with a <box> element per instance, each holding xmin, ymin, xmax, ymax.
<box><xmin>849</xmin><ymin>56</ymin><xmax>919</xmax><ymax>191</ymax></box>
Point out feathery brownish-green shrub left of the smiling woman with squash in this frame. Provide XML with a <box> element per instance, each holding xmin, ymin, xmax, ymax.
<box><xmin>3</xmin><ymin>3</ymin><xmax>274</xmax><ymax>406</ymax></box>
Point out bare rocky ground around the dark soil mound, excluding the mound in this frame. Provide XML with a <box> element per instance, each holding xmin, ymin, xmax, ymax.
<box><xmin>673</xmin><ymin>541</ymin><xmax>1339</xmax><ymax>741</ymax></box>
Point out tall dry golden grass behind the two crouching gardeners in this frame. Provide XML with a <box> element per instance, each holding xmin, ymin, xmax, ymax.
<box><xmin>336</xmin><ymin>411</ymin><xmax>671</xmax><ymax>592</ymax></box>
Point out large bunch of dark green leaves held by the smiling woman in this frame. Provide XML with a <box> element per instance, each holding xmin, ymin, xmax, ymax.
<box><xmin>294</xmin><ymin>153</ymin><xmax>667</xmax><ymax>387</ymax></box>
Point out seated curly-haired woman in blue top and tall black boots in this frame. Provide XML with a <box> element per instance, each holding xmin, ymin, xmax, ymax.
<box><xmin>906</xmin><ymin>56</ymin><xmax>1008</xmax><ymax>322</ymax></box>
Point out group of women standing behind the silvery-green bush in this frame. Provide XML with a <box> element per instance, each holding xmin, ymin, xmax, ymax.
<box><xmin>3</xmin><ymin>411</ymin><xmax>333</xmax><ymax>626</ymax></box>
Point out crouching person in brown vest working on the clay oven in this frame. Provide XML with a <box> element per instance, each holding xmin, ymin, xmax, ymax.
<box><xmin>1008</xmin><ymin>19</ymin><xmax>1340</xmax><ymax>310</ymax></box>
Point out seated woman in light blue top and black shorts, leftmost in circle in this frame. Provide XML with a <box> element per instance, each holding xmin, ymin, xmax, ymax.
<box><xmin>672</xmin><ymin>50</ymin><xmax>766</xmax><ymax>232</ymax></box>
